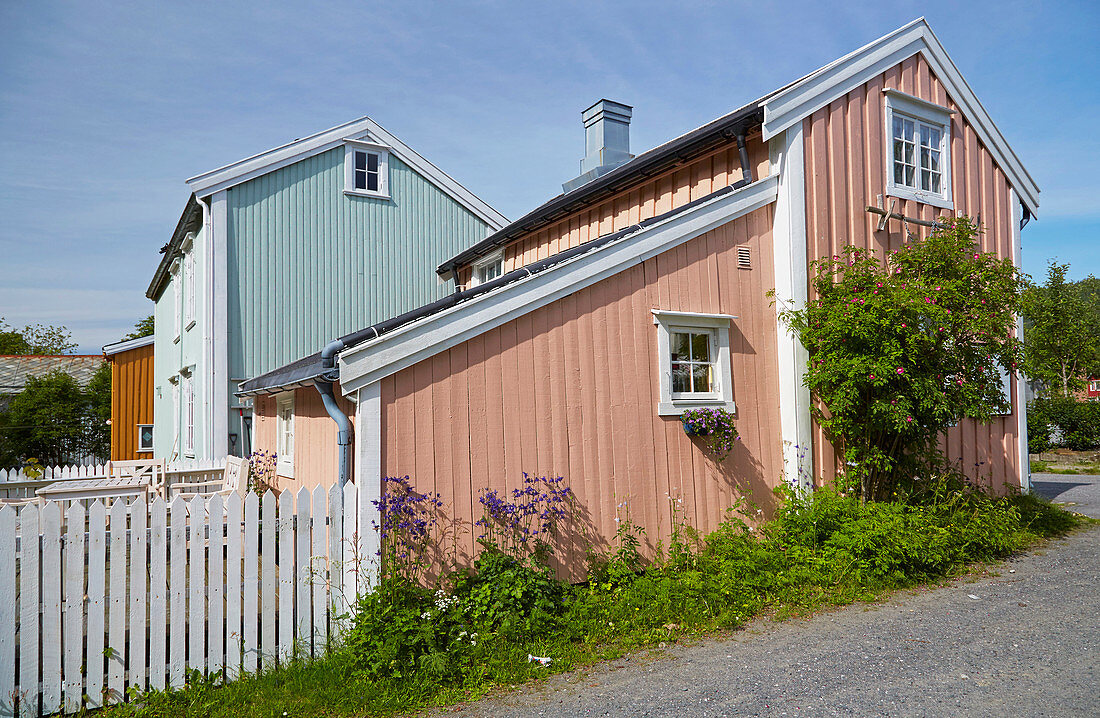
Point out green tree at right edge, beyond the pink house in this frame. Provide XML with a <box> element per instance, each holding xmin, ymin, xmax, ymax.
<box><xmin>1023</xmin><ymin>262</ymin><xmax>1100</xmax><ymax>396</ymax></box>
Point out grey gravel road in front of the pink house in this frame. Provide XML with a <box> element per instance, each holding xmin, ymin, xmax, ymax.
<box><xmin>442</xmin><ymin>474</ymin><xmax>1100</xmax><ymax>717</ymax></box>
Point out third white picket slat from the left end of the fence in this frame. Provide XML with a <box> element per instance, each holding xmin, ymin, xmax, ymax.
<box><xmin>41</xmin><ymin>501</ymin><xmax>64</xmax><ymax>715</ymax></box>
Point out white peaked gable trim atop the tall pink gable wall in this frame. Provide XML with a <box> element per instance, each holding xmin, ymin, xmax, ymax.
<box><xmin>763</xmin><ymin>18</ymin><xmax>1040</xmax><ymax>216</ymax></box>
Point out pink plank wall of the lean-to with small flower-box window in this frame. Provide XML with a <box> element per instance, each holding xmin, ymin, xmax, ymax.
<box><xmin>382</xmin><ymin>205</ymin><xmax>782</xmax><ymax>577</ymax></box>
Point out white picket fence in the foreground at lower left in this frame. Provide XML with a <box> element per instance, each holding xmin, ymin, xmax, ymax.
<box><xmin>0</xmin><ymin>484</ymin><xmax>374</xmax><ymax>716</ymax></box>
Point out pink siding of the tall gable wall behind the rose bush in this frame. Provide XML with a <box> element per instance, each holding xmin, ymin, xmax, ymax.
<box><xmin>803</xmin><ymin>55</ymin><xmax>1020</xmax><ymax>490</ymax></box>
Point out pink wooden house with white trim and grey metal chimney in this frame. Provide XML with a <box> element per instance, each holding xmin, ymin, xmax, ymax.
<box><xmin>242</xmin><ymin>19</ymin><xmax>1038</xmax><ymax>570</ymax></box>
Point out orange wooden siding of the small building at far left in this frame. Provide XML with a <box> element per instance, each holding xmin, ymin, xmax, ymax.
<box><xmin>110</xmin><ymin>344</ymin><xmax>155</xmax><ymax>461</ymax></box>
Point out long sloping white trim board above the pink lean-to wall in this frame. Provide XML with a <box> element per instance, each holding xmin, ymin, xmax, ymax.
<box><xmin>340</xmin><ymin>175</ymin><xmax>779</xmax><ymax>394</ymax></box>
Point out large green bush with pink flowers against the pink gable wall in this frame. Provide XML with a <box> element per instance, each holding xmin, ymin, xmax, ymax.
<box><xmin>780</xmin><ymin>217</ymin><xmax>1024</xmax><ymax>499</ymax></box>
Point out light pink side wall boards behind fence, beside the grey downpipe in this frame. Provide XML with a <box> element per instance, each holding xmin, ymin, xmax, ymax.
<box><xmin>252</xmin><ymin>387</ymin><xmax>355</xmax><ymax>491</ymax></box>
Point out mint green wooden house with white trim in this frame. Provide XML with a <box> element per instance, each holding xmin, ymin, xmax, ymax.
<box><xmin>146</xmin><ymin>118</ymin><xmax>507</xmax><ymax>460</ymax></box>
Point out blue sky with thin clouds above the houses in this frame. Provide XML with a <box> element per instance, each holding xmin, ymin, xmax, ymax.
<box><xmin>0</xmin><ymin>0</ymin><xmax>1100</xmax><ymax>352</ymax></box>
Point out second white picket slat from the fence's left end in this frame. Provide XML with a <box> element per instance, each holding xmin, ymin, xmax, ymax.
<box><xmin>17</xmin><ymin>504</ymin><xmax>42</xmax><ymax>716</ymax></box>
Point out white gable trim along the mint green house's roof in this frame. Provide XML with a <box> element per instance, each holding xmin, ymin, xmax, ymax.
<box><xmin>187</xmin><ymin>117</ymin><xmax>508</xmax><ymax>230</ymax></box>
